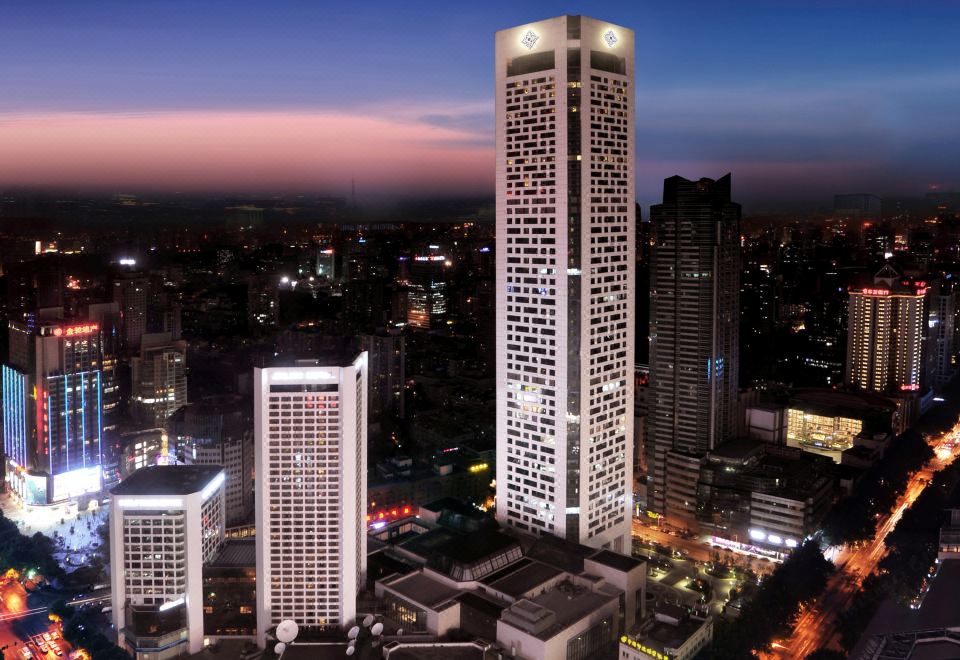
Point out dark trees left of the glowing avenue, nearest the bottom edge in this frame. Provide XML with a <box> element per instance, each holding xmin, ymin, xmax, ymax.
<box><xmin>704</xmin><ymin>541</ymin><xmax>834</xmax><ymax>660</ymax></box>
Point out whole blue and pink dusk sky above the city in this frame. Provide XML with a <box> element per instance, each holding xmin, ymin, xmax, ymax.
<box><xmin>0</xmin><ymin>0</ymin><xmax>960</xmax><ymax>209</ymax></box>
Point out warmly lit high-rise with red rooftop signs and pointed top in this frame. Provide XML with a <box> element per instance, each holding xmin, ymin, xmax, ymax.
<box><xmin>845</xmin><ymin>264</ymin><xmax>927</xmax><ymax>395</ymax></box>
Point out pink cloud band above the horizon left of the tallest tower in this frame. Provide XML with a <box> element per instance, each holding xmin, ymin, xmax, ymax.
<box><xmin>0</xmin><ymin>111</ymin><xmax>493</xmax><ymax>193</ymax></box>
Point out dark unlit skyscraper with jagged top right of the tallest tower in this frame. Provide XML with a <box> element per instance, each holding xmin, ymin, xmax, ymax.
<box><xmin>648</xmin><ymin>174</ymin><xmax>740</xmax><ymax>520</ymax></box>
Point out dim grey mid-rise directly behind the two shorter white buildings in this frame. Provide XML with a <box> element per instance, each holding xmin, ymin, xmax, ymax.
<box><xmin>167</xmin><ymin>396</ymin><xmax>254</xmax><ymax>526</ymax></box>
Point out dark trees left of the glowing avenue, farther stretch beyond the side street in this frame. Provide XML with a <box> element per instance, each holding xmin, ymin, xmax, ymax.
<box><xmin>823</xmin><ymin>431</ymin><xmax>933</xmax><ymax>545</ymax></box>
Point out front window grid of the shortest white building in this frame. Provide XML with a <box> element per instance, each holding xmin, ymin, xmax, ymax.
<box><xmin>123</xmin><ymin>511</ymin><xmax>187</xmax><ymax>605</ymax></box>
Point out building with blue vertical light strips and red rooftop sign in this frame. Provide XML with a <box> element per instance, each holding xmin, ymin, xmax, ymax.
<box><xmin>3</xmin><ymin>308</ymin><xmax>103</xmax><ymax>505</ymax></box>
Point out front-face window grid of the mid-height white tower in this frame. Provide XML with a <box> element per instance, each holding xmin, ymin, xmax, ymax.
<box><xmin>267</xmin><ymin>392</ymin><xmax>342</xmax><ymax>627</ymax></box>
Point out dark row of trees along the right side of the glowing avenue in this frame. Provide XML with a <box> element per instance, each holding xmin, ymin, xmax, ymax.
<box><xmin>838</xmin><ymin>463</ymin><xmax>960</xmax><ymax>650</ymax></box>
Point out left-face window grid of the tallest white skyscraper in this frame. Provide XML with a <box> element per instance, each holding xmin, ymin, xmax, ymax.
<box><xmin>505</xmin><ymin>72</ymin><xmax>566</xmax><ymax>532</ymax></box>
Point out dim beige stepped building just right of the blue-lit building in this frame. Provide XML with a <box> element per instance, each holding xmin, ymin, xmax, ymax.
<box><xmin>130</xmin><ymin>332</ymin><xmax>187</xmax><ymax>427</ymax></box>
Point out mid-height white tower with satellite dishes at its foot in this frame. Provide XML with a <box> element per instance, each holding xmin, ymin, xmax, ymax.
<box><xmin>254</xmin><ymin>352</ymin><xmax>367</xmax><ymax>646</ymax></box>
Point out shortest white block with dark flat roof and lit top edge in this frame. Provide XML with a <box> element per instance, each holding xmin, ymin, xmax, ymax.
<box><xmin>110</xmin><ymin>465</ymin><xmax>225</xmax><ymax>660</ymax></box>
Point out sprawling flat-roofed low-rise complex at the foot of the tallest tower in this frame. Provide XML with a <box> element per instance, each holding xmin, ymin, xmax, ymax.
<box><xmin>375</xmin><ymin>523</ymin><xmax>646</xmax><ymax>660</ymax></box>
